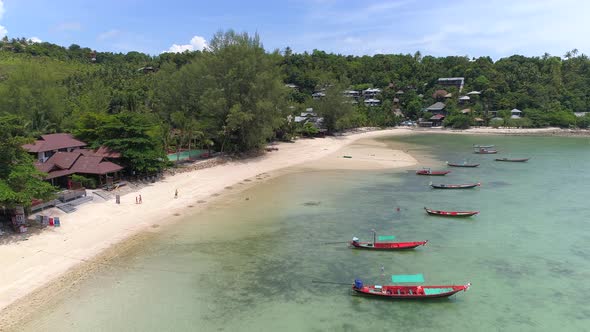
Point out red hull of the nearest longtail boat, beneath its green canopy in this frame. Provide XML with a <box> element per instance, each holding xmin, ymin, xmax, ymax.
<box><xmin>352</xmin><ymin>279</ymin><xmax>471</xmax><ymax>300</ymax></box>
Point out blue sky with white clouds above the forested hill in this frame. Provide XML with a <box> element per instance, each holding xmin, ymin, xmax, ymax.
<box><xmin>0</xmin><ymin>0</ymin><xmax>590</xmax><ymax>59</ymax></box>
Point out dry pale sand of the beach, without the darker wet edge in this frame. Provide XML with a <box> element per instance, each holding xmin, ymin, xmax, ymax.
<box><xmin>0</xmin><ymin>129</ymin><xmax>416</xmax><ymax>316</ymax></box>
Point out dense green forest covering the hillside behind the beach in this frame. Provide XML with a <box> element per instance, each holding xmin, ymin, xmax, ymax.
<box><xmin>0</xmin><ymin>34</ymin><xmax>590</xmax><ymax>166</ymax></box>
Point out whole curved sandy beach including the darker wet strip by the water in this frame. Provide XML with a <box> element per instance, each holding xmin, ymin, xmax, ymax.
<box><xmin>0</xmin><ymin>128</ymin><xmax>417</xmax><ymax>330</ymax></box>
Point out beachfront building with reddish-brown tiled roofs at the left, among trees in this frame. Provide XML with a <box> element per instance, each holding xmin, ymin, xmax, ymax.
<box><xmin>23</xmin><ymin>133</ymin><xmax>123</xmax><ymax>188</ymax></box>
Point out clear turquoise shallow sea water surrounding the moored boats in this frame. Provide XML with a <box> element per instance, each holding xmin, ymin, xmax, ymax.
<box><xmin>23</xmin><ymin>135</ymin><xmax>590</xmax><ymax>331</ymax></box>
